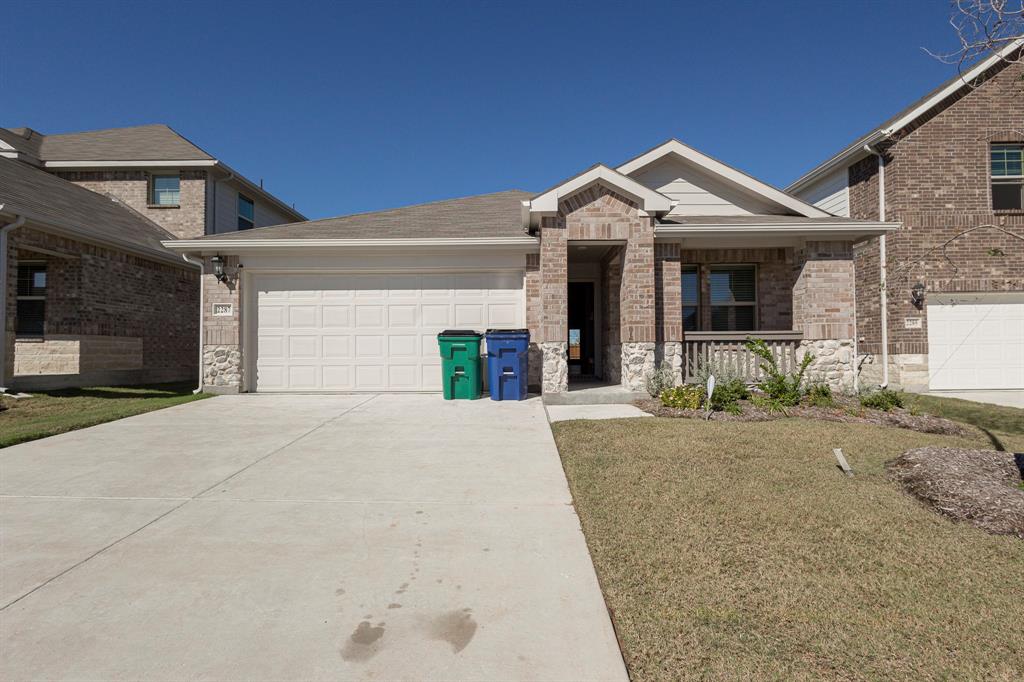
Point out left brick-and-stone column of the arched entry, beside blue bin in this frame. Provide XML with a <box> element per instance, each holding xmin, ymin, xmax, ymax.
<box><xmin>538</xmin><ymin>216</ymin><xmax>569</xmax><ymax>393</ymax></box>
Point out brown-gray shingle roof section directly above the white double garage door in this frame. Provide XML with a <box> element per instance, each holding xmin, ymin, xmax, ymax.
<box><xmin>194</xmin><ymin>189</ymin><xmax>532</xmax><ymax>241</ymax></box>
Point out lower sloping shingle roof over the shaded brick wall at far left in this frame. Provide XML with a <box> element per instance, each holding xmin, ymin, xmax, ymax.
<box><xmin>0</xmin><ymin>158</ymin><xmax>175</xmax><ymax>259</ymax></box>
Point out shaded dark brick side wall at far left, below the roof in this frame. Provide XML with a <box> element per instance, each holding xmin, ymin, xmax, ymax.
<box><xmin>5</xmin><ymin>226</ymin><xmax>199</xmax><ymax>388</ymax></box>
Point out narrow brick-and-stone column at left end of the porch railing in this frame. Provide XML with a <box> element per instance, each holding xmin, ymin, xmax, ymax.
<box><xmin>654</xmin><ymin>244</ymin><xmax>683</xmax><ymax>384</ymax></box>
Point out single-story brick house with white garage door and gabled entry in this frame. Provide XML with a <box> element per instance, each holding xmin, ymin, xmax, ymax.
<box><xmin>159</xmin><ymin>140</ymin><xmax>898</xmax><ymax>394</ymax></box>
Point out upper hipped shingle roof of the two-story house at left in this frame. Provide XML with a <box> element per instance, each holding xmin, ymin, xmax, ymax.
<box><xmin>32</xmin><ymin>124</ymin><xmax>214</xmax><ymax>161</ymax></box>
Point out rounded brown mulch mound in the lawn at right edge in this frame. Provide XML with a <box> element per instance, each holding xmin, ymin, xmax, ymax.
<box><xmin>889</xmin><ymin>447</ymin><xmax>1024</xmax><ymax>539</ymax></box>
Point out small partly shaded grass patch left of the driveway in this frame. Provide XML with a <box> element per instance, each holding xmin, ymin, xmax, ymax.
<box><xmin>0</xmin><ymin>384</ymin><xmax>208</xmax><ymax>447</ymax></box>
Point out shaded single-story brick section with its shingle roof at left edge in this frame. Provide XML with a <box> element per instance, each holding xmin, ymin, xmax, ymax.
<box><xmin>0</xmin><ymin>158</ymin><xmax>199</xmax><ymax>390</ymax></box>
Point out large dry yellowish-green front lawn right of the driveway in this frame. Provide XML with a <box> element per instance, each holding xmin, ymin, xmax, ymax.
<box><xmin>553</xmin><ymin>411</ymin><xmax>1024</xmax><ymax>681</ymax></box>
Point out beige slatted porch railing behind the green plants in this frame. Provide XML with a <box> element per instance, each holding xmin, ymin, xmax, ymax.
<box><xmin>683</xmin><ymin>332</ymin><xmax>804</xmax><ymax>382</ymax></box>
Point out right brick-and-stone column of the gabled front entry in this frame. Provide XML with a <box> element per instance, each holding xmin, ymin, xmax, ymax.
<box><xmin>620</xmin><ymin>215</ymin><xmax>656</xmax><ymax>391</ymax></box>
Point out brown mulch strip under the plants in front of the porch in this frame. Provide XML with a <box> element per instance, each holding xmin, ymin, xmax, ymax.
<box><xmin>634</xmin><ymin>398</ymin><xmax>970</xmax><ymax>436</ymax></box>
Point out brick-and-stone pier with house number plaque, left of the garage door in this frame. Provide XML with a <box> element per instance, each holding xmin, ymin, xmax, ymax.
<box><xmin>203</xmin><ymin>256</ymin><xmax>243</xmax><ymax>393</ymax></box>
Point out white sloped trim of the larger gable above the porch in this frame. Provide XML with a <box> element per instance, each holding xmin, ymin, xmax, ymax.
<box><xmin>616</xmin><ymin>139</ymin><xmax>828</xmax><ymax>218</ymax></box>
